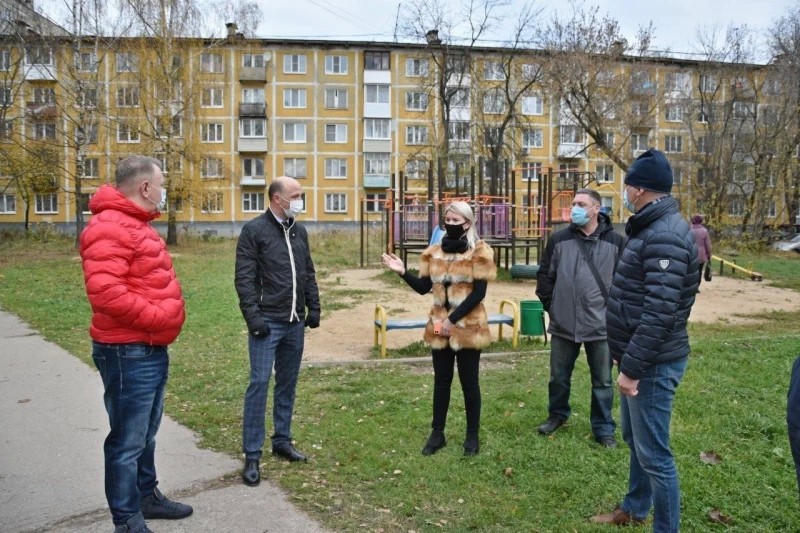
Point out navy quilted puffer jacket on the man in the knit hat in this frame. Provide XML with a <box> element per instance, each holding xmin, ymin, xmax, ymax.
<box><xmin>606</xmin><ymin>196</ymin><xmax>700</xmax><ymax>379</ymax></box>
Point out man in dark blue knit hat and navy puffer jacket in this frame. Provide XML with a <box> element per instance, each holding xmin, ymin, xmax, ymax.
<box><xmin>592</xmin><ymin>149</ymin><xmax>700</xmax><ymax>532</ymax></box>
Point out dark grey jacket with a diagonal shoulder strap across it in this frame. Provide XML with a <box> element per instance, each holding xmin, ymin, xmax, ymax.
<box><xmin>536</xmin><ymin>213</ymin><xmax>625</xmax><ymax>342</ymax></box>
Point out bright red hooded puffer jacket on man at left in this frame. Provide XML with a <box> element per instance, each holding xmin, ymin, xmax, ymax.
<box><xmin>81</xmin><ymin>185</ymin><xmax>186</xmax><ymax>345</ymax></box>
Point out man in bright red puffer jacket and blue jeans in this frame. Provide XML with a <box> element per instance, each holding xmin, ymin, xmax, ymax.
<box><xmin>80</xmin><ymin>156</ymin><xmax>192</xmax><ymax>533</ymax></box>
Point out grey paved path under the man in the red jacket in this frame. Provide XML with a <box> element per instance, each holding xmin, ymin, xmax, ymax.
<box><xmin>0</xmin><ymin>310</ymin><xmax>330</xmax><ymax>533</ymax></box>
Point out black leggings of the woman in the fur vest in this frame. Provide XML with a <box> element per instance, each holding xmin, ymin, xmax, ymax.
<box><xmin>431</xmin><ymin>346</ymin><xmax>481</xmax><ymax>435</ymax></box>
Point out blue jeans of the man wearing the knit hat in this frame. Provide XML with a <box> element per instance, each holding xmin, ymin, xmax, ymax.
<box><xmin>620</xmin><ymin>358</ymin><xmax>688</xmax><ymax>533</ymax></box>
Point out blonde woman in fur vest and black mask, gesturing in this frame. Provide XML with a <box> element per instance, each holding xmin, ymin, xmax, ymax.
<box><xmin>382</xmin><ymin>202</ymin><xmax>497</xmax><ymax>456</ymax></box>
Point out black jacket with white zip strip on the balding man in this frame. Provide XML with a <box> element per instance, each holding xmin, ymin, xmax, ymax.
<box><xmin>234</xmin><ymin>210</ymin><xmax>320</xmax><ymax>332</ymax></box>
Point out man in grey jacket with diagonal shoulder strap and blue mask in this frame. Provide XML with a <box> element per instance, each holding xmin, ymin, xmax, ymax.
<box><xmin>536</xmin><ymin>189</ymin><xmax>625</xmax><ymax>448</ymax></box>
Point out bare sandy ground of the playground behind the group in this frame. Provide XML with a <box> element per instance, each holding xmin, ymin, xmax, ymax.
<box><xmin>304</xmin><ymin>269</ymin><xmax>800</xmax><ymax>362</ymax></box>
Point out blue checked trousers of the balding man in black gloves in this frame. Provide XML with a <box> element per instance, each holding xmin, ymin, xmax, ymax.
<box><xmin>242</xmin><ymin>319</ymin><xmax>305</xmax><ymax>459</ymax></box>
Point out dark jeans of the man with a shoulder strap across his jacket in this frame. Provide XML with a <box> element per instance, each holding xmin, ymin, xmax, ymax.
<box><xmin>548</xmin><ymin>335</ymin><xmax>617</xmax><ymax>438</ymax></box>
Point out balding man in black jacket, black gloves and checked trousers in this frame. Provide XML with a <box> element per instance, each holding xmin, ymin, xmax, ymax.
<box><xmin>235</xmin><ymin>176</ymin><xmax>320</xmax><ymax>486</ymax></box>
